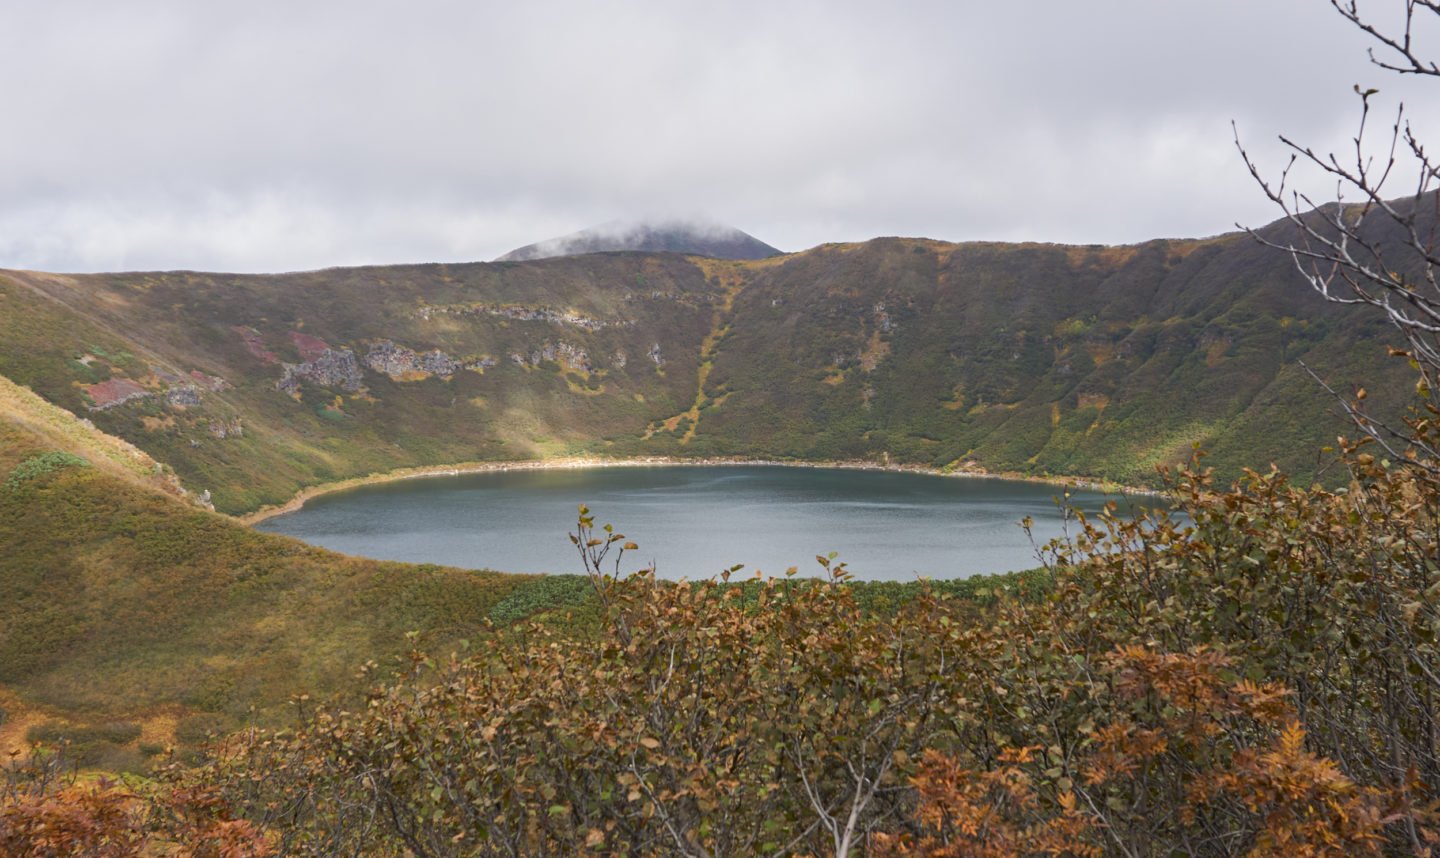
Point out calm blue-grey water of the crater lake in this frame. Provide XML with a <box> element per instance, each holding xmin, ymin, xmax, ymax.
<box><xmin>256</xmin><ymin>465</ymin><xmax>1152</xmax><ymax>580</ymax></box>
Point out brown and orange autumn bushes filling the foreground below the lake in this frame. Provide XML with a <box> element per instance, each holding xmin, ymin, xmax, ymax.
<box><xmin>16</xmin><ymin>445</ymin><xmax>1405</xmax><ymax>857</ymax></box>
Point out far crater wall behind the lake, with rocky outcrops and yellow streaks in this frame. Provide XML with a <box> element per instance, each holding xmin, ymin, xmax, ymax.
<box><xmin>0</xmin><ymin>217</ymin><xmax>1407</xmax><ymax>512</ymax></box>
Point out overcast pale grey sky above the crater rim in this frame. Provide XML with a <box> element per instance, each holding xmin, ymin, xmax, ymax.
<box><xmin>0</xmin><ymin>0</ymin><xmax>1440</xmax><ymax>271</ymax></box>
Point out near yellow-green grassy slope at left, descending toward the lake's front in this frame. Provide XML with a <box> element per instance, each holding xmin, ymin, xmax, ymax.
<box><xmin>0</xmin><ymin>380</ymin><xmax>540</xmax><ymax>766</ymax></box>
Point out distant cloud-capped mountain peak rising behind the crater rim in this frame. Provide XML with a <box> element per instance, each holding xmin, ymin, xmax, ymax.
<box><xmin>495</xmin><ymin>220</ymin><xmax>780</xmax><ymax>262</ymax></box>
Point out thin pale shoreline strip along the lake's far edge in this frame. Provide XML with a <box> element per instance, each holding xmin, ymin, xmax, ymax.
<box><xmin>233</xmin><ymin>456</ymin><xmax>1162</xmax><ymax>525</ymax></box>
